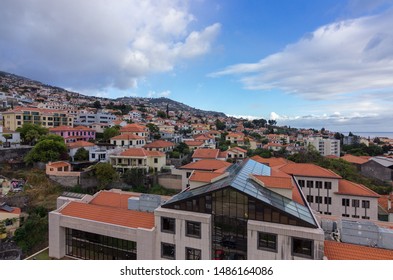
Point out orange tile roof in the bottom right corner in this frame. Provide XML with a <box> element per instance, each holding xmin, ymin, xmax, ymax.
<box><xmin>324</xmin><ymin>240</ymin><xmax>393</xmax><ymax>260</ymax></box>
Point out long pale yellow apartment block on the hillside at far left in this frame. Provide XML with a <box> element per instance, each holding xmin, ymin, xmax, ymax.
<box><xmin>3</xmin><ymin>107</ymin><xmax>74</xmax><ymax>130</ymax></box>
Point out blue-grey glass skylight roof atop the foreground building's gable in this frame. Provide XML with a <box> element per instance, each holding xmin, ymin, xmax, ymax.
<box><xmin>164</xmin><ymin>159</ymin><xmax>317</xmax><ymax>226</ymax></box>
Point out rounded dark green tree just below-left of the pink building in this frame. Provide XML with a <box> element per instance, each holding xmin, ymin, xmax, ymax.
<box><xmin>24</xmin><ymin>134</ymin><xmax>68</xmax><ymax>164</ymax></box>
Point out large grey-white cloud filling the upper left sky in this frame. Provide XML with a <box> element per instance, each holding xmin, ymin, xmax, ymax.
<box><xmin>0</xmin><ymin>0</ymin><xmax>220</xmax><ymax>93</ymax></box>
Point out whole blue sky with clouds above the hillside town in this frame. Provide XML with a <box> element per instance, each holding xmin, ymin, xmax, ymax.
<box><xmin>0</xmin><ymin>0</ymin><xmax>393</xmax><ymax>132</ymax></box>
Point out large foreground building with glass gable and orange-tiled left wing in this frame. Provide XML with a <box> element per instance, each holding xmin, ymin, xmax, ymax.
<box><xmin>49</xmin><ymin>160</ymin><xmax>324</xmax><ymax>260</ymax></box>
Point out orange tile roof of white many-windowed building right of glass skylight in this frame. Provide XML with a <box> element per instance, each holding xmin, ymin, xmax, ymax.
<box><xmin>280</xmin><ymin>163</ymin><xmax>341</xmax><ymax>179</ymax></box>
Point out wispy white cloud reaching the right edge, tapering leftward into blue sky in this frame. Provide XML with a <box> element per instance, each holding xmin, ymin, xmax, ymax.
<box><xmin>211</xmin><ymin>10</ymin><xmax>393</xmax><ymax>100</ymax></box>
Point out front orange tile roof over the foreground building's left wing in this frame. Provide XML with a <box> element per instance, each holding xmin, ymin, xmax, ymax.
<box><xmin>60</xmin><ymin>201</ymin><xmax>154</xmax><ymax>229</ymax></box>
